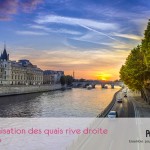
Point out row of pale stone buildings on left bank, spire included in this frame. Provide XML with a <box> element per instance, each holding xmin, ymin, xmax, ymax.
<box><xmin>0</xmin><ymin>45</ymin><xmax>64</xmax><ymax>85</ymax></box>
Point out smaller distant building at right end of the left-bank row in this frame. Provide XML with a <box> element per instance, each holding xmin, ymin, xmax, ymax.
<box><xmin>43</xmin><ymin>70</ymin><xmax>64</xmax><ymax>84</ymax></box>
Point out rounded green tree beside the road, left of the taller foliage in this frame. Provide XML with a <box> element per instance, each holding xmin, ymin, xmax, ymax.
<box><xmin>120</xmin><ymin>45</ymin><xmax>146</xmax><ymax>90</ymax></box>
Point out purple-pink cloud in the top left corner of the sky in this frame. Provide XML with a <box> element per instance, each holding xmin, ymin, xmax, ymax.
<box><xmin>0</xmin><ymin>0</ymin><xmax>43</xmax><ymax>21</ymax></box>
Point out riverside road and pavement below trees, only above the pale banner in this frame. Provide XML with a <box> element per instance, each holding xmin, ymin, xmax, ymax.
<box><xmin>112</xmin><ymin>90</ymin><xmax>150</xmax><ymax>118</ymax></box>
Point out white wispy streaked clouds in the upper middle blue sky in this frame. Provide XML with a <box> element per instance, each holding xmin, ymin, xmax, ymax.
<box><xmin>35</xmin><ymin>15</ymin><xmax>123</xmax><ymax>44</ymax></box>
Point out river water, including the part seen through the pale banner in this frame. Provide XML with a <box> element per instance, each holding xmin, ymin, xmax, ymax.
<box><xmin>0</xmin><ymin>87</ymin><xmax>119</xmax><ymax>150</ymax></box>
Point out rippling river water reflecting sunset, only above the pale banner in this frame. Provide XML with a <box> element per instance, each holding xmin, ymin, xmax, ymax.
<box><xmin>0</xmin><ymin>86</ymin><xmax>119</xmax><ymax>118</ymax></box>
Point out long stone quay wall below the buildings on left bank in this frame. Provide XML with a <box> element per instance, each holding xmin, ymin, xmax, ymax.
<box><xmin>0</xmin><ymin>84</ymin><xmax>61</xmax><ymax>96</ymax></box>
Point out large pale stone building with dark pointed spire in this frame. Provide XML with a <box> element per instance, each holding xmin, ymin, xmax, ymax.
<box><xmin>0</xmin><ymin>46</ymin><xmax>43</xmax><ymax>85</ymax></box>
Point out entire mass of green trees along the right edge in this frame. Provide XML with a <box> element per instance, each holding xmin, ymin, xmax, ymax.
<box><xmin>120</xmin><ymin>19</ymin><xmax>150</xmax><ymax>91</ymax></box>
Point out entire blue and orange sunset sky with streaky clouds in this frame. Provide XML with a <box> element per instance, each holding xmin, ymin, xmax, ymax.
<box><xmin>0</xmin><ymin>0</ymin><xmax>150</xmax><ymax>80</ymax></box>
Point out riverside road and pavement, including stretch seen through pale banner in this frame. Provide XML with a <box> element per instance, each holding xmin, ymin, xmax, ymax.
<box><xmin>68</xmin><ymin>91</ymin><xmax>150</xmax><ymax>150</ymax></box>
